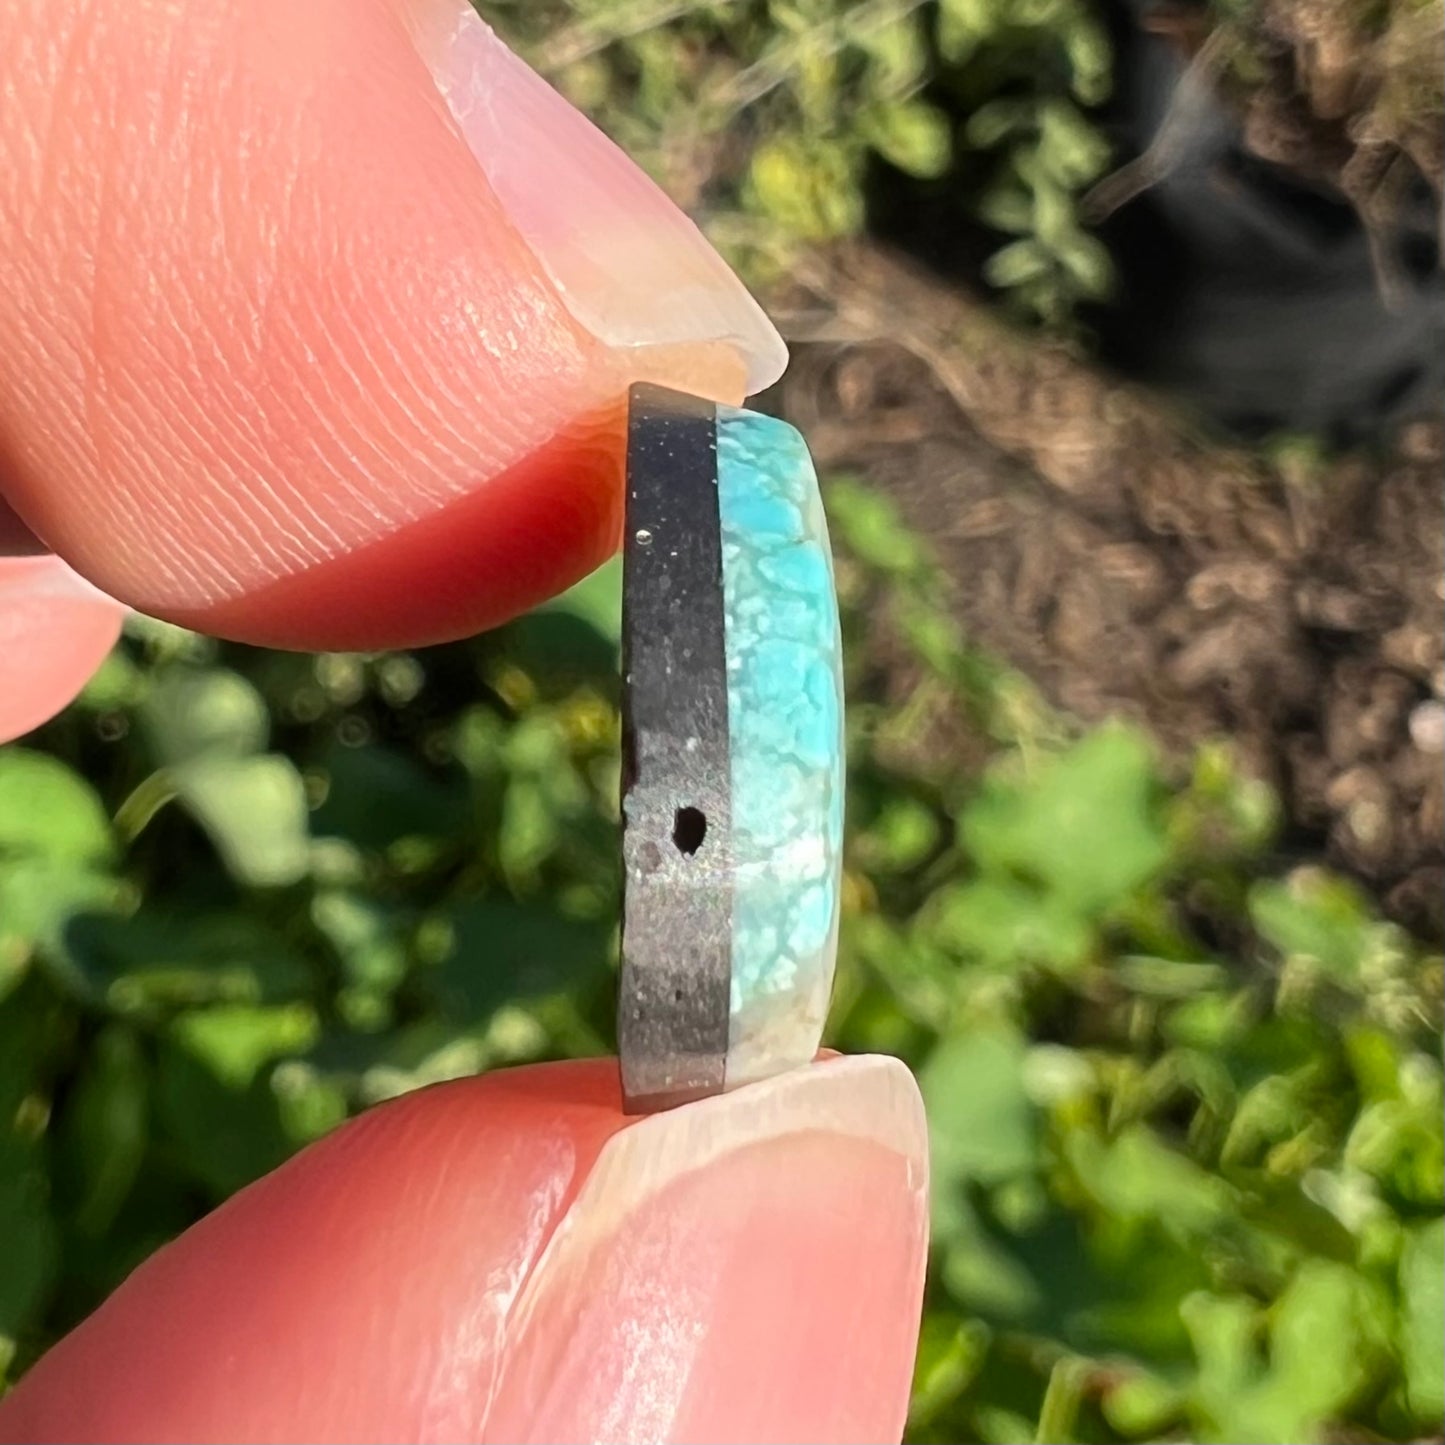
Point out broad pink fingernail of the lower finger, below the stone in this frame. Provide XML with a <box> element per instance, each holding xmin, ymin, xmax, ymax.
<box><xmin>488</xmin><ymin>1058</ymin><xmax>928</xmax><ymax>1442</ymax></box>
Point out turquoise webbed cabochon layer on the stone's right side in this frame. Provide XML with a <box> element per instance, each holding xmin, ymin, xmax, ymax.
<box><xmin>717</xmin><ymin>406</ymin><xmax>844</xmax><ymax>1087</ymax></box>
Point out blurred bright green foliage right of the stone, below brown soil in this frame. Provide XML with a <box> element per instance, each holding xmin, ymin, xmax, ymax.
<box><xmin>831</xmin><ymin>487</ymin><xmax>1445</xmax><ymax>1442</ymax></box>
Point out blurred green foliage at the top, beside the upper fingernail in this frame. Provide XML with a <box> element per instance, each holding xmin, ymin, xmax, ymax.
<box><xmin>497</xmin><ymin>0</ymin><xmax>1111</xmax><ymax>324</ymax></box>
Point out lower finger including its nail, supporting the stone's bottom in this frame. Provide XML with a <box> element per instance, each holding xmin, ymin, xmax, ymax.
<box><xmin>0</xmin><ymin>1059</ymin><xmax>926</xmax><ymax>1442</ymax></box>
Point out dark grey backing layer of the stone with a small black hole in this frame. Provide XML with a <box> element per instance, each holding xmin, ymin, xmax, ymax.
<box><xmin>617</xmin><ymin>386</ymin><xmax>733</xmax><ymax>1113</ymax></box>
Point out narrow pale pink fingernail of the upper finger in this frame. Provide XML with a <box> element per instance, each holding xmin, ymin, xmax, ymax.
<box><xmin>405</xmin><ymin>0</ymin><xmax>788</xmax><ymax>393</ymax></box>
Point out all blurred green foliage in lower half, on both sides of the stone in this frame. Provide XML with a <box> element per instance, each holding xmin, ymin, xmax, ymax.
<box><xmin>0</xmin><ymin>480</ymin><xmax>1445</xmax><ymax>1442</ymax></box>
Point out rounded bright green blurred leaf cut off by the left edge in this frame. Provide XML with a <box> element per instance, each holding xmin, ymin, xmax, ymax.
<box><xmin>0</xmin><ymin>747</ymin><xmax>116</xmax><ymax>867</ymax></box>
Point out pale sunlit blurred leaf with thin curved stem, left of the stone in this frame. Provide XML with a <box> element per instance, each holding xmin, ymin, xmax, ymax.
<box><xmin>171</xmin><ymin>753</ymin><xmax>309</xmax><ymax>887</ymax></box>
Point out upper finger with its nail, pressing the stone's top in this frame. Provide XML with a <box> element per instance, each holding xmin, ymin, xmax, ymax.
<box><xmin>0</xmin><ymin>0</ymin><xmax>785</xmax><ymax>647</ymax></box>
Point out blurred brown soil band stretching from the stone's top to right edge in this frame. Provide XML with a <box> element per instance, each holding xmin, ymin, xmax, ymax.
<box><xmin>775</xmin><ymin>239</ymin><xmax>1445</xmax><ymax>936</ymax></box>
